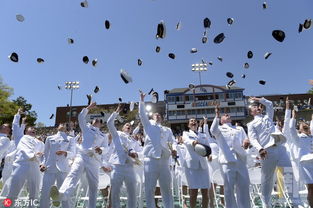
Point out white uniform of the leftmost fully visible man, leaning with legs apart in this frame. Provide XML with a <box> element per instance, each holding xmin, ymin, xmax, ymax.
<box><xmin>7</xmin><ymin>135</ymin><xmax>43</xmax><ymax>207</ymax></box>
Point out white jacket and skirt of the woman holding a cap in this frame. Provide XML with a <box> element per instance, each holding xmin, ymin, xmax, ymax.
<box><xmin>183</xmin><ymin>130</ymin><xmax>210</xmax><ymax>189</ymax></box>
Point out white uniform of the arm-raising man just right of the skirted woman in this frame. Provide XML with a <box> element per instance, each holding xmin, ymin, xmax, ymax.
<box><xmin>211</xmin><ymin>117</ymin><xmax>250</xmax><ymax>208</ymax></box>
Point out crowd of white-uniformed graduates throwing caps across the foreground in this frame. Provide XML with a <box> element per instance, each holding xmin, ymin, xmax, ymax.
<box><xmin>0</xmin><ymin>92</ymin><xmax>313</xmax><ymax>208</ymax></box>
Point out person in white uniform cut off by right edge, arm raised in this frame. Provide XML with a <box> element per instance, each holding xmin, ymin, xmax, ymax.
<box><xmin>290</xmin><ymin>110</ymin><xmax>313</xmax><ymax>207</ymax></box>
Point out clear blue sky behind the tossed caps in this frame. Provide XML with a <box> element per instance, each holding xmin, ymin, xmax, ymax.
<box><xmin>0</xmin><ymin>0</ymin><xmax>313</xmax><ymax>125</ymax></box>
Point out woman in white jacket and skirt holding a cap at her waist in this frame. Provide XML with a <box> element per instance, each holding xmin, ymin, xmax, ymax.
<box><xmin>183</xmin><ymin>118</ymin><xmax>210</xmax><ymax>208</ymax></box>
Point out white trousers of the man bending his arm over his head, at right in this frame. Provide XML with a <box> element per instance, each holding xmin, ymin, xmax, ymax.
<box><xmin>261</xmin><ymin>145</ymin><xmax>291</xmax><ymax>208</ymax></box>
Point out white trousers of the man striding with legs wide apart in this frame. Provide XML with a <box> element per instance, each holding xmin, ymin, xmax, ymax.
<box><xmin>59</xmin><ymin>154</ymin><xmax>99</xmax><ymax>208</ymax></box>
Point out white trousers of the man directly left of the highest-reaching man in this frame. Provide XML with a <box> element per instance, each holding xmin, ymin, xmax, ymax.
<box><xmin>111</xmin><ymin>165</ymin><xmax>137</xmax><ymax>208</ymax></box>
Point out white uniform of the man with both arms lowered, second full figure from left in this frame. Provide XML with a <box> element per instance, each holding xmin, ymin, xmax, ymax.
<box><xmin>40</xmin><ymin>131</ymin><xmax>76</xmax><ymax>208</ymax></box>
